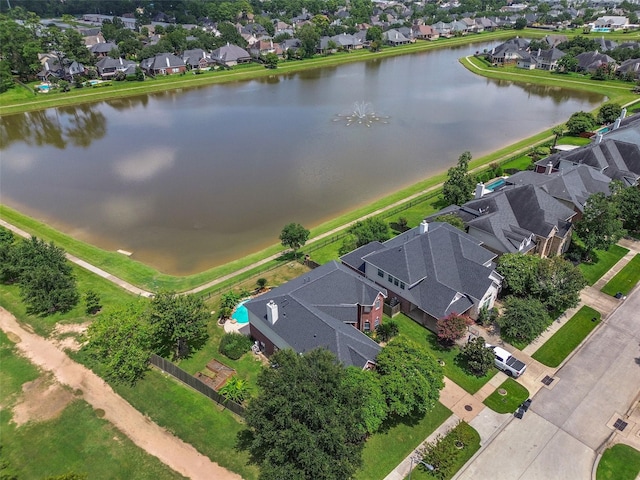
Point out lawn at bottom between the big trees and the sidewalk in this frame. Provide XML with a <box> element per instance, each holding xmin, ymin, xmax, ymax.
<box><xmin>355</xmin><ymin>402</ymin><xmax>451</xmax><ymax>480</ymax></box>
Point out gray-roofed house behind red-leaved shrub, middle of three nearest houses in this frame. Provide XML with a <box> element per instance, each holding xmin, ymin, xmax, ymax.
<box><xmin>341</xmin><ymin>221</ymin><xmax>502</xmax><ymax>330</ymax></box>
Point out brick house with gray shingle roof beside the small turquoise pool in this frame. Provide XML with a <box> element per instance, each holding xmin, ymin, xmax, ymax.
<box><xmin>245</xmin><ymin>261</ymin><xmax>387</xmax><ymax>368</ymax></box>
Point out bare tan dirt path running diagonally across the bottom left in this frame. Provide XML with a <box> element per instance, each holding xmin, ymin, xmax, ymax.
<box><xmin>0</xmin><ymin>308</ymin><xmax>241</xmax><ymax>480</ymax></box>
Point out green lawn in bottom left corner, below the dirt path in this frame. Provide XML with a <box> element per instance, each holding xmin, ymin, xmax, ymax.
<box><xmin>0</xmin><ymin>332</ymin><xmax>183</xmax><ymax>480</ymax></box>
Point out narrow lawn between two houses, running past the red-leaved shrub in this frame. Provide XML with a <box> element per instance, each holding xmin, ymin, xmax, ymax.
<box><xmin>393</xmin><ymin>314</ymin><xmax>498</xmax><ymax>394</ymax></box>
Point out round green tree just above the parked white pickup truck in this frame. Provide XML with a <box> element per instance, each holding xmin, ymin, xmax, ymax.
<box><xmin>498</xmin><ymin>296</ymin><xmax>549</xmax><ymax>343</ymax></box>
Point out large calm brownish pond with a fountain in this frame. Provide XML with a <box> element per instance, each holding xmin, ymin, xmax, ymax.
<box><xmin>0</xmin><ymin>44</ymin><xmax>603</xmax><ymax>274</ymax></box>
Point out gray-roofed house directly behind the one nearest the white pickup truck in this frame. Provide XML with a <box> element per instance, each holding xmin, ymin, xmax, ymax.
<box><xmin>448</xmin><ymin>184</ymin><xmax>576</xmax><ymax>257</ymax></box>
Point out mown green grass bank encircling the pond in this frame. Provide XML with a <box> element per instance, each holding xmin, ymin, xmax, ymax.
<box><xmin>0</xmin><ymin>31</ymin><xmax>639</xmax><ymax>292</ymax></box>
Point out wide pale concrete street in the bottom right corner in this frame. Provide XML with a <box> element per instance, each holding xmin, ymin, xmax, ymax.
<box><xmin>456</xmin><ymin>288</ymin><xmax>640</xmax><ymax>480</ymax></box>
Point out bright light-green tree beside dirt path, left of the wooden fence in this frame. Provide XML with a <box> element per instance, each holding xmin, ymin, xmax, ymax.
<box><xmin>83</xmin><ymin>301</ymin><xmax>153</xmax><ymax>385</ymax></box>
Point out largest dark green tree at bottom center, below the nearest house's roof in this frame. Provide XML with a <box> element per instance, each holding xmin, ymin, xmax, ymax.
<box><xmin>245</xmin><ymin>349</ymin><xmax>366</xmax><ymax>480</ymax></box>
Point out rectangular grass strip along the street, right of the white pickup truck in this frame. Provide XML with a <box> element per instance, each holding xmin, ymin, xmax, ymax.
<box><xmin>532</xmin><ymin>305</ymin><xmax>600</xmax><ymax>368</ymax></box>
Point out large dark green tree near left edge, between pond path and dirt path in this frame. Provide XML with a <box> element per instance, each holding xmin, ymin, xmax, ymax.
<box><xmin>11</xmin><ymin>237</ymin><xmax>79</xmax><ymax>315</ymax></box>
